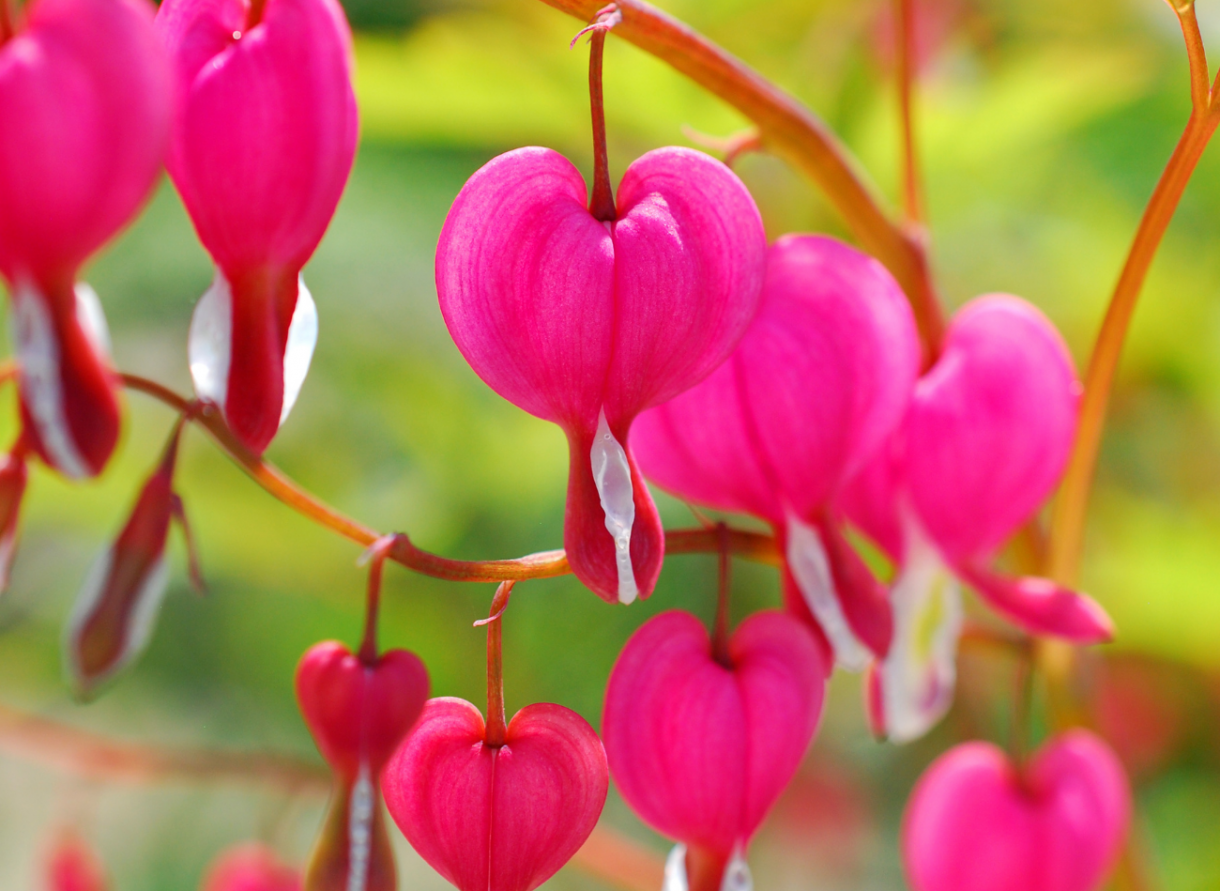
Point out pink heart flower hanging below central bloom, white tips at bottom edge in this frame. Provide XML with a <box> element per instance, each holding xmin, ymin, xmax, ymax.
<box><xmin>601</xmin><ymin>611</ymin><xmax>830</xmax><ymax>887</ymax></box>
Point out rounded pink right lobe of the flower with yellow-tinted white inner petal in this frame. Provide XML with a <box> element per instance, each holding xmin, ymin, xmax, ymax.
<box><xmin>906</xmin><ymin>294</ymin><xmax>1080</xmax><ymax>563</ymax></box>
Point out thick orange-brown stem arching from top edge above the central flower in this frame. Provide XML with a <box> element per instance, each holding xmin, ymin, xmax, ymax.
<box><xmin>531</xmin><ymin>0</ymin><xmax>944</xmax><ymax>359</ymax></box>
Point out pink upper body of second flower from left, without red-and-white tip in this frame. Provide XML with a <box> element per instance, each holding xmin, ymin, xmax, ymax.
<box><xmin>157</xmin><ymin>0</ymin><xmax>357</xmax><ymax>274</ymax></box>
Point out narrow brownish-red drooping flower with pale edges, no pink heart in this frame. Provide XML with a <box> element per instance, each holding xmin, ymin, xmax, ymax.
<box><xmin>63</xmin><ymin>421</ymin><xmax>201</xmax><ymax>697</ymax></box>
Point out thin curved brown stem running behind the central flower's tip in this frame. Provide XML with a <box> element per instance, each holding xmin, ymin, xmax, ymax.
<box><xmin>121</xmin><ymin>375</ymin><xmax>780</xmax><ymax>582</ymax></box>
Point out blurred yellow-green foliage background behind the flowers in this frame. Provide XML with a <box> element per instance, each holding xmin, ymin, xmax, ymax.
<box><xmin>0</xmin><ymin>0</ymin><xmax>1220</xmax><ymax>891</ymax></box>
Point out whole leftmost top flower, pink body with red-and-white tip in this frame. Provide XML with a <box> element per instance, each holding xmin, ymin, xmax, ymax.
<box><xmin>0</xmin><ymin>0</ymin><xmax>170</xmax><ymax>478</ymax></box>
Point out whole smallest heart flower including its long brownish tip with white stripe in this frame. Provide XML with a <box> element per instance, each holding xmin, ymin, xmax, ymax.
<box><xmin>296</xmin><ymin>641</ymin><xmax>428</xmax><ymax>891</ymax></box>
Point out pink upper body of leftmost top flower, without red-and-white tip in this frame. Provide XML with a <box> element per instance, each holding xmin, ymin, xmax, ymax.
<box><xmin>0</xmin><ymin>0</ymin><xmax>171</xmax><ymax>290</ymax></box>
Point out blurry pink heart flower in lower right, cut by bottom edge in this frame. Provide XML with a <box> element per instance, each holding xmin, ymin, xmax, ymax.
<box><xmin>903</xmin><ymin>730</ymin><xmax>1131</xmax><ymax>891</ymax></box>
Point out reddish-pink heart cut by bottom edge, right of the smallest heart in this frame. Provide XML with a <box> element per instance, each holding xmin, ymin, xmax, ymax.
<box><xmin>382</xmin><ymin>698</ymin><xmax>610</xmax><ymax>891</ymax></box>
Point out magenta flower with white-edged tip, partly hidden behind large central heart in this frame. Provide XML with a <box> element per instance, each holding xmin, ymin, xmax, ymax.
<box><xmin>632</xmin><ymin>236</ymin><xmax>919</xmax><ymax>670</ymax></box>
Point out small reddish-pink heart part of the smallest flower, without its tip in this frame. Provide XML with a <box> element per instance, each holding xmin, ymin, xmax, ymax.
<box><xmin>296</xmin><ymin>641</ymin><xmax>428</xmax><ymax>780</ymax></box>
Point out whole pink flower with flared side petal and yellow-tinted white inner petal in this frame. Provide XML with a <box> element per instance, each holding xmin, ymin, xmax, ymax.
<box><xmin>841</xmin><ymin>294</ymin><xmax>1113</xmax><ymax>740</ymax></box>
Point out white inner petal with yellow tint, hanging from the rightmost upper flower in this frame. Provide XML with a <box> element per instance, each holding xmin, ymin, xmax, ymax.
<box><xmin>881</xmin><ymin>525</ymin><xmax>963</xmax><ymax>742</ymax></box>
